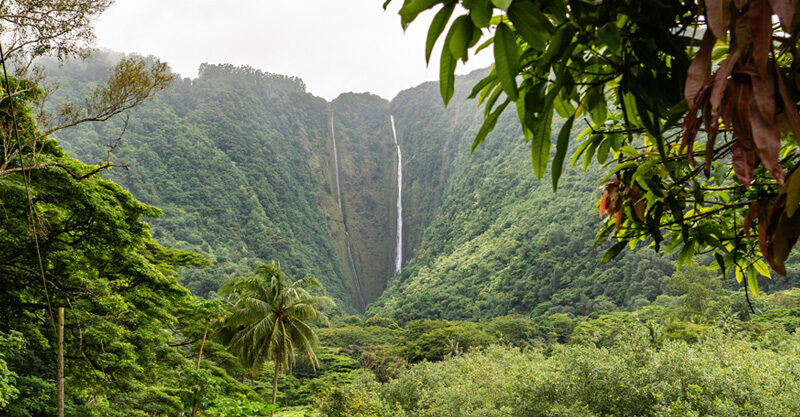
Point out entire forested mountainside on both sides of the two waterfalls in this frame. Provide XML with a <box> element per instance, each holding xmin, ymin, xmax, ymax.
<box><xmin>47</xmin><ymin>53</ymin><xmax>800</xmax><ymax>323</ymax></box>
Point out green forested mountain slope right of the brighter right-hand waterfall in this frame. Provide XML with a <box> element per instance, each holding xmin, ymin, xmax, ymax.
<box><xmin>370</xmin><ymin>74</ymin><xmax>673</xmax><ymax>321</ymax></box>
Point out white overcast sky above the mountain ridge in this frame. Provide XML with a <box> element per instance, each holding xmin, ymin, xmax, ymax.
<box><xmin>96</xmin><ymin>0</ymin><xmax>491</xmax><ymax>100</ymax></box>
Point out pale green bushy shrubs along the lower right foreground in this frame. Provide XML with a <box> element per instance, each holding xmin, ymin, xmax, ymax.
<box><xmin>322</xmin><ymin>333</ymin><xmax>800</xmax><ymax>417</ymax></box>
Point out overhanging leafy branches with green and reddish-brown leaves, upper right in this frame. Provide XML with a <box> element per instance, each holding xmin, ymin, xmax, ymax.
<box><xmin>386</xmin><ymin>0</ymin><xmax>800</xmax><ymax>293</ymax></box>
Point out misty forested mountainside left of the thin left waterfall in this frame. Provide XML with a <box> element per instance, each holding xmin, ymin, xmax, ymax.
<box><xmin>47</xmin><ymin>53</ymin><xmax>350</xmax><ymax>304</ymax></box>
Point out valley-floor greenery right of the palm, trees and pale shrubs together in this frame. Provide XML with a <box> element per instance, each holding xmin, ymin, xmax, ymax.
<box><xmin>239</xmin><ymin>267</ymin><xmax>800</xmax><ymax>417</ymax></box>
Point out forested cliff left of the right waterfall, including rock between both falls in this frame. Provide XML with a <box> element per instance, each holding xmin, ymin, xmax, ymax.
<box><xmin>48</xmin><ymin>54</ymin><xmax>406</xmax><ymax>311</ymax></box>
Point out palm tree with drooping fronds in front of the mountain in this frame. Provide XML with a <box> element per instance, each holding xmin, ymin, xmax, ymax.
<box><xmin>217</xmin><ymin>261</ymin><xmax>333</xmax><ymax>415</ymax></box>
